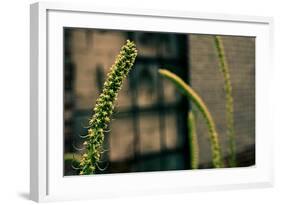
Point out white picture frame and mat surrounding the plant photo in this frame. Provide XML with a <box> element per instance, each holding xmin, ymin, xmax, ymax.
<box><xmin>30</xmin><ymin>2</ymin><xmax>273</xmax><ymax>202</ymax></box>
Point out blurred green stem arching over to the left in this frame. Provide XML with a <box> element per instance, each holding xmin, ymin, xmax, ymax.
<box><xmin>159</xmin><ymin>69</ymin><xmax>223</xmax><ymax>168</ymax></box>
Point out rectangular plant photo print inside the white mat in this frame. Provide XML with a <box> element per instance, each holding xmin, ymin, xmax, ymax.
<box><xmin>62</xmin><ymin>27</ymin><xmax>255</xmax><ymax>176</ymax></box>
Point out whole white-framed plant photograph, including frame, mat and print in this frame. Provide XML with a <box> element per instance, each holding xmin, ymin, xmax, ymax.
<box><xmin>30</xmin><ymin>3</ymin><xmax>273</xmax><ymax>202</ymax></box>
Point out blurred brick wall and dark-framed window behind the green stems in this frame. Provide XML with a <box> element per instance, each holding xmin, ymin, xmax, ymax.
<box><xmin>64</xmin><ymin>28</ymin><xmax>255</xmax><ymax>175</ymax></box>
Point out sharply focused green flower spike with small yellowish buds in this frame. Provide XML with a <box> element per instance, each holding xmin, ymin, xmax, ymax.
<box><xmin>80</xmin><ymin>40</ymin><xmax>137</xmax><ymax>175</ymax></box>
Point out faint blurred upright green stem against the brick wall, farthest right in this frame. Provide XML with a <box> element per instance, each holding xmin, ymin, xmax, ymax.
<box><xmin>214</xmin><ymin>36</ymin><xmax>236</xmax><ymax>167</ymax></box>
